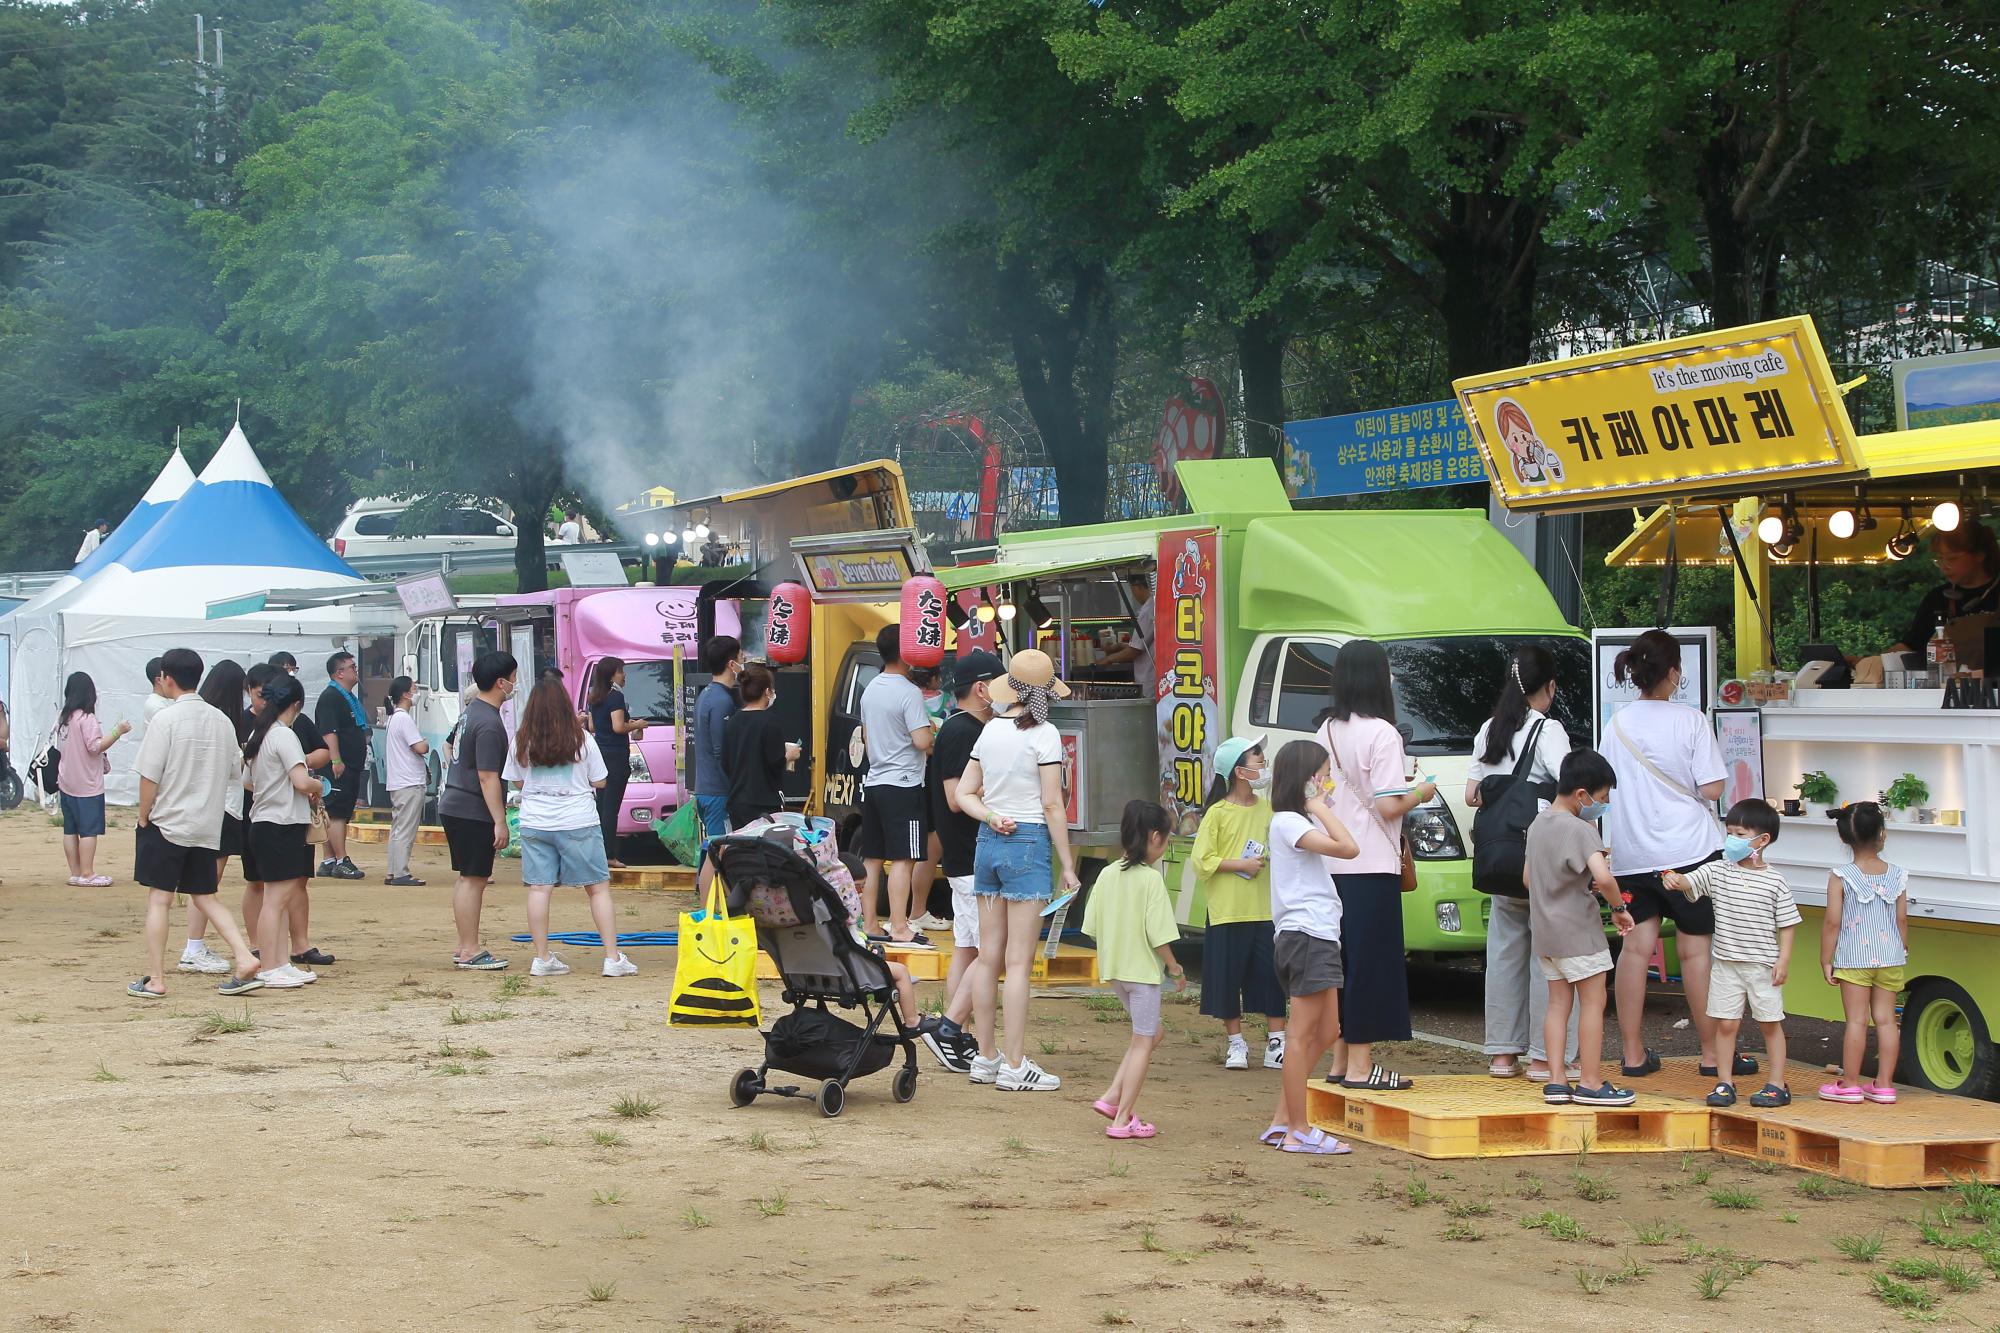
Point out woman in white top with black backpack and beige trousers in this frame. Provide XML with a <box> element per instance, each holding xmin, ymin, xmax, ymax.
<box><xmin>1466</xmin><ymin>642</ymin><xmax>1576</xmax><ymax>1083</ymax></box>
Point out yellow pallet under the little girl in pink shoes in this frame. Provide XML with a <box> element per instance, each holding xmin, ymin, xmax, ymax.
<box><xmin>1634</xmin><ymin>1059</ymin><xmax>2000</xmax><ymax>1189</ymax></box>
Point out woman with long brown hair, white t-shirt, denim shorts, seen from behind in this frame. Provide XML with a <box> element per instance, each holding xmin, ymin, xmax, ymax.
<box><xmin>500</xmin><ymin>681</ymin><xmax>638</xmax><ymax>977</ymax></box>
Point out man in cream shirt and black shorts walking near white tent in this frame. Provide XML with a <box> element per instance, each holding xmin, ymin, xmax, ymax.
<box><xmin>126</xmin><ymin>648</ymin><xmax>262</xmax><ymax>999</ymax></box>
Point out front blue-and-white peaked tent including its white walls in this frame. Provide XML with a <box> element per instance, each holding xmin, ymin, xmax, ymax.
<box><xmin>0</xmin><ymin>426</ymin><xmax>364</xmax><ymax>805</ymax></box>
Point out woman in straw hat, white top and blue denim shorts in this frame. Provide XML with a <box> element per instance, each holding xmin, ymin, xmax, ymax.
<box><xmin>958</xmin><ymin>648</ymin><xmax>1080</xmax><ymax>1093</ymax></box>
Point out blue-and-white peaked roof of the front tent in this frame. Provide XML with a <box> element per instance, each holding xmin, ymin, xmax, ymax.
<box><xmin>62</xmin><ymin>424</ymin><xmax>362</xmax><ymax>618</ymax></box>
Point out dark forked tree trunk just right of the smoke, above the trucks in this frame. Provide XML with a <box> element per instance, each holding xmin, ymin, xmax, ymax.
<box><xmin>1000</xmin><ymin>260</ymin><xmax>1118</xmax><ymax>526</ymax></box>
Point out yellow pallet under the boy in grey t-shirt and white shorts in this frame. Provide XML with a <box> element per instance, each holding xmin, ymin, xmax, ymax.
<box><xmin>1306</xmin><ymin>1075</ymin><xmax>1708</xmax><ymax>1159</ymax></box>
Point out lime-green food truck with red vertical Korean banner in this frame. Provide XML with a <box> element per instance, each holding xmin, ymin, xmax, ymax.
<box><xmin>936</xmin><ymin>458</ymin><xmax>1588</xmax><ymax>955</ymax></box>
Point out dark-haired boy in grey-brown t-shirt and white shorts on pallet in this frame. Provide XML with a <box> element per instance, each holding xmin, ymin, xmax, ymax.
<box><xmin>1522</xmin><ymin>751</ymin><xmax>1636</xmax><ymax>1107</ymax></box>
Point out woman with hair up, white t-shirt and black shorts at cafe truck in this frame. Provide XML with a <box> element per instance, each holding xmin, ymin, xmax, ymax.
<box><xmin>1600</xmin><ymin>628</ymin><xmax>1756</xmax><ymax>1079</ymax></box>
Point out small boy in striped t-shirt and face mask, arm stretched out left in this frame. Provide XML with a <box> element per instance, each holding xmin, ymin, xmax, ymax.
<box><xmin>1660</xmin><ymin>799</ymin><xmax>1798</xmax><ymax>1107</ymax></box>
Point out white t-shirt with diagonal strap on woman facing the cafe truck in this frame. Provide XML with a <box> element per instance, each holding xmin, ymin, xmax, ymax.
<box><xmin>1598</xmin><ymin>699</ymin><xmax>1728</xmax><ymax>875</ymax></box>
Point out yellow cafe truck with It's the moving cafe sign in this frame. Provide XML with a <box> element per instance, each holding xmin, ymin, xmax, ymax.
<box><xmin>1454</xmin><ymin>318</ymin><xmax>2000</xmax><ymax>1097</ymax></box>
